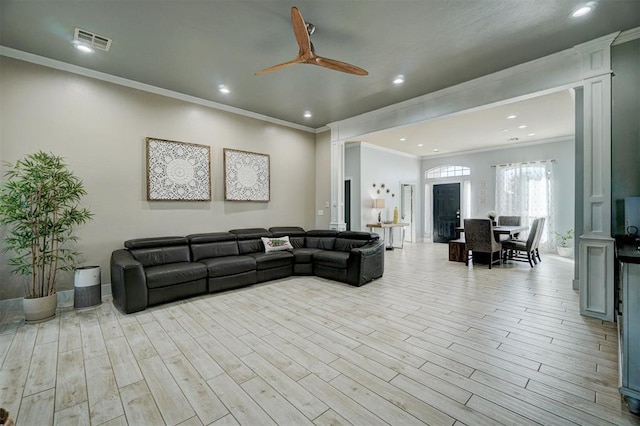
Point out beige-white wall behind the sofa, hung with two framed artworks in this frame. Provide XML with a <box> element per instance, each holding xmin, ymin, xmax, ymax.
<box><xmin>0</xmin><ymin>57</ymin><xmax>318</xmax><ymax>299</ymax></box>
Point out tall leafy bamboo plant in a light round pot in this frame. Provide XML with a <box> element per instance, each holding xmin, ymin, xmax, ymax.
<box><xmin>0</xmin><ymin>151</ymin><xmax>92</xmax><ymax>322</ymax></box>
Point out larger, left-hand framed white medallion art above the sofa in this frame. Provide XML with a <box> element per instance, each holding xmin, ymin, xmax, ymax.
<box><xmin>147</xmin><ymin>138</ymin><xmax>211</xmax><ymax>201</ymax></box>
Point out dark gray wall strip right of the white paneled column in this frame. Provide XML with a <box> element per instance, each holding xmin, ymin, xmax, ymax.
<box><xmin>611</xmin><ymin>40</ymin><xmax>640</xmax><ymax>235</ymax></box>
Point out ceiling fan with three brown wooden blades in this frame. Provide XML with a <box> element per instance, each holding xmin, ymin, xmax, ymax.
<box><xmin>256</xmin><ymin>6</ymin><xmax>369</xmax><ymax>75</ymax></box>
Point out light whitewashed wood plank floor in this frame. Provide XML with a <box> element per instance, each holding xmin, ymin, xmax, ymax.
<box><xmin>0</xmin><ymin>243</ymin><xmax>640</xmax><ymax>426</ymax></box>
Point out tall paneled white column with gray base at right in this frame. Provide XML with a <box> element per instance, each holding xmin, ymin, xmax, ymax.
<box><xmin>576</xmin><ymin>34</ymin><xmax>617</xmax><ymax>321</ymax></box>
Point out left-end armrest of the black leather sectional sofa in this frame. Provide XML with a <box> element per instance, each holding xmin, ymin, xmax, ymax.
<box><xmin>111</xmin><ymin>249</ymin><xmax>148</xmax><ymax>314</ymax></box>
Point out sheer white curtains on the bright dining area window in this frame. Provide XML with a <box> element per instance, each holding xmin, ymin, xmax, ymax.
<box><xmin>496</xmin><ymin>161</ymin><xmax>554</xmax><ymax>249</ymax></box>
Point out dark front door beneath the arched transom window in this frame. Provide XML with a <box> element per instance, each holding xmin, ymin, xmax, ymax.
<box><xmin>433</xmin><ymin>183</ymin><xmax>460</xmax><ymax>243</ymax></box>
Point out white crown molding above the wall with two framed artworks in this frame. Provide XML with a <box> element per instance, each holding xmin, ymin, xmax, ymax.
<box><xmin>0</xmin><ymin>45</ymin><xmax>318</xmax><ymax>134</ymax></box>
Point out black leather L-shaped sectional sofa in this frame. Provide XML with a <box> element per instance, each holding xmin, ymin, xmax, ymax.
<box><xmin>111</xmin><ymin>227</ymin><xmax>384</xmax><ymax>314</ymax></box>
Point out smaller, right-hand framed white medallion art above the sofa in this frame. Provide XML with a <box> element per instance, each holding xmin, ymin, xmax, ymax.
<box><xmin>223</xmin><ymin>148</ymin><xmax>271</xmax><ymax>202</ymax></box>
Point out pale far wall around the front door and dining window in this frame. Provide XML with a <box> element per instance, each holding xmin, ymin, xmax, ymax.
<box><xmin>421</xmin><ymin>139</ymin><xmax>575</xmax><ymax>240</ymax></box>
